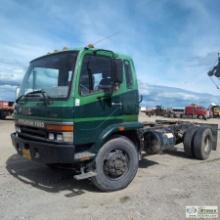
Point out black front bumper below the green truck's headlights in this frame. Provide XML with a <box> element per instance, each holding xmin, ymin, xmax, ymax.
<box><xmin>11</xmin><ymin>133</ymin><xmax>75</xmax><ymax>164</ymax></box>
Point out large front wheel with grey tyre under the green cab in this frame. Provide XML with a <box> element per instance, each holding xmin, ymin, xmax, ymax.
<box><xmin>92</xmin><ymin>136</ymin><xmax>138</xmax><ymax>191</ymax></box>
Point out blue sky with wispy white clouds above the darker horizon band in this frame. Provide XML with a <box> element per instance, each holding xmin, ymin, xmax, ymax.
<box><xmin>0</xmin><ymin>0</ymin><xmax>220</xmax><ymax>94</ymax></box>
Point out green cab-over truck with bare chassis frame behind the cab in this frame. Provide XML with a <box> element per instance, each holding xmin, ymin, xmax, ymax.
<box><xmin>11</xmin><ymin>47</ymin><xmax>218</xmax><ymax>191</ymax></box>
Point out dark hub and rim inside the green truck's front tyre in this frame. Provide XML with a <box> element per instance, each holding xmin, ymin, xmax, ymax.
<box><xmin>103</xmin><ymin>149</ymin><xmax>129</xmax><ymax>180</ymax></box>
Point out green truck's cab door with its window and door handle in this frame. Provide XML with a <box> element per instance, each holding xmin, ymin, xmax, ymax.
<box><xmin>74</xmin><ymin>54</ymin><xmax>122</xmax><ymax>144</ymax></box>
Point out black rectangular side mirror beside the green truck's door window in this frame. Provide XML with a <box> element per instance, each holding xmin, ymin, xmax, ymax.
<box><xmin>112</xmin><ymin>59</ymin><xmax>123</xmax><ymax>84</ymax></box>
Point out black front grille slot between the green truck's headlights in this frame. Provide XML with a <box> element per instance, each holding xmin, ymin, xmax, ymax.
<box><xmin>19</xmin><ymin>125</ymin><xmax>48</xmax><ymax>139</ymax></box>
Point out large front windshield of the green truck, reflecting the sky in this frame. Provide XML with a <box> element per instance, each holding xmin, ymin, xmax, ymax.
<box><xmin>19</xmin><ymin>51</ymin><xmax>77</xmax><ymax>98</ymax></box>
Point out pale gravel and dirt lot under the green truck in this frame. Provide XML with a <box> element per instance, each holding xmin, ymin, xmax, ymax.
<box><xmin>0</xmin><ymin>116</ymin><xmax>220</xmax><ymax>220</ymax></box>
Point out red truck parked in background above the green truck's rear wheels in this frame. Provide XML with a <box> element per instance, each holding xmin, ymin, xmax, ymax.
<box><xmin>185</xmin><ymin>104</ymin><xmax>210</xmax><ymax>119</ymax></box>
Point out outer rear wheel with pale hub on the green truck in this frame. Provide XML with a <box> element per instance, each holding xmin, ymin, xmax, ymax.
<box><xmin>193</xmin><ymin>127</ymin><xmax>213</xmax><ymax>160</ymax></box>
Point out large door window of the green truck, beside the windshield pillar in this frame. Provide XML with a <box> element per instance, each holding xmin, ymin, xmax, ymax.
<box><xmin>79</xmin><ymin>55</ymin><xmax>113</xmax><ymax>95</ymax></box>
